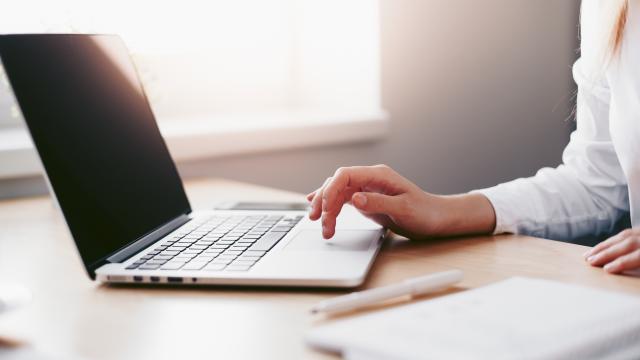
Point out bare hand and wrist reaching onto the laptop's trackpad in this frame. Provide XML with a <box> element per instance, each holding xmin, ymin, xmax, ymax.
<box><xmin>307</xmin><ymin>165</ymin><xmax>495</xmax><ymax>239</ymax></box>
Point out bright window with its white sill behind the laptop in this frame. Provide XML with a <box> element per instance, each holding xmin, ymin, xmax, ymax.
<box><xmin>0</xmin><ymin>0</ymin><xmax>386</xmax><ymax>176</ymax></box>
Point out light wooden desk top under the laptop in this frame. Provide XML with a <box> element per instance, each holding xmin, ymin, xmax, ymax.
<box><xmin>0</xmin><ymin>180</ymin><xmax>640</xmax><ymax>359</ymax></box>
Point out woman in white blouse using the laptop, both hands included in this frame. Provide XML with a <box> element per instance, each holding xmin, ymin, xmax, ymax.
<box><xmin>307</xmin><ymin>0</ymin><xmax>640</xmax><ymax>273</ymax></box>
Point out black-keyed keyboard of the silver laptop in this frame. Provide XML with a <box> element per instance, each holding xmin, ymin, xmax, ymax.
<box><xmin>126</xmin><ymin>215</ymin><xmax>302</xmax><ymax>271</ymax></box>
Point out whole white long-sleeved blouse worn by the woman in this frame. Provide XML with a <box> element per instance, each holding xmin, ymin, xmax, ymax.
<box><xmin>476</xmin><ymin>0</ymin><xmax>640</xmax><ymax>240</ymax></box>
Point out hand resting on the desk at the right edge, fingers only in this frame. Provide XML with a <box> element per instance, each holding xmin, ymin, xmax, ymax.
<box><xmin>584</xmin><ymin>229</ymin><xmax>640</xmax><ymax>274</ymax></box>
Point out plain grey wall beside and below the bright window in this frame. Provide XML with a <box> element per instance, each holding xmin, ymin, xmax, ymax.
<box><xmin>0</xmin><ymin>0</ymin><xmax>579</xmax><ymax>194</ymax></box>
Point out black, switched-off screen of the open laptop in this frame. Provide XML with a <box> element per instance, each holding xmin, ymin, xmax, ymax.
<box><xmin>0</xmin><ymin>35</ymin><xmax>191</xmax><ymax>274</ymax></box>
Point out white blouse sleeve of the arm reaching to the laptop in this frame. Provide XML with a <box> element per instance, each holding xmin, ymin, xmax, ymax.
<box><xmin>474</xmin><ymin>1</ymin><xmax>629</xmax><ymax>240</ymax></box>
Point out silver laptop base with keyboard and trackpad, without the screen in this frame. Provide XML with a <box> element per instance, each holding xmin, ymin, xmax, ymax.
<box><xmin>96</xmin><ymin>206</ymin><xmax>384</xmax><ymax>287</ymax></box>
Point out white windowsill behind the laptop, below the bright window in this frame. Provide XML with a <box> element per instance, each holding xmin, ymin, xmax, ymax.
<box><xmin>0</xmin><ymin>110</ymin><xmax>388</xmax><ymax>179</ymax></box>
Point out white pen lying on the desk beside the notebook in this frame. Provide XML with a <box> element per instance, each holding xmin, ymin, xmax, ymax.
<box><xmin>311</xmin><ymin>270</ymin><xmax>462</xmax><ymax>314</ymax></box>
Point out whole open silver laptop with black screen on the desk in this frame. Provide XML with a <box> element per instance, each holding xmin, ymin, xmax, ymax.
<box><xmin>0</xmin><ymin>34</ymin><xmax>385</xmax><ymax>287</ymax></box>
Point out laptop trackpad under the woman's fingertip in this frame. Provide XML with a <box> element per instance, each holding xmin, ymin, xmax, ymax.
<box><xmin>284</xmin><ymin>230</ymin><xmax>379</xmax><ymax>251</ymax></box>
